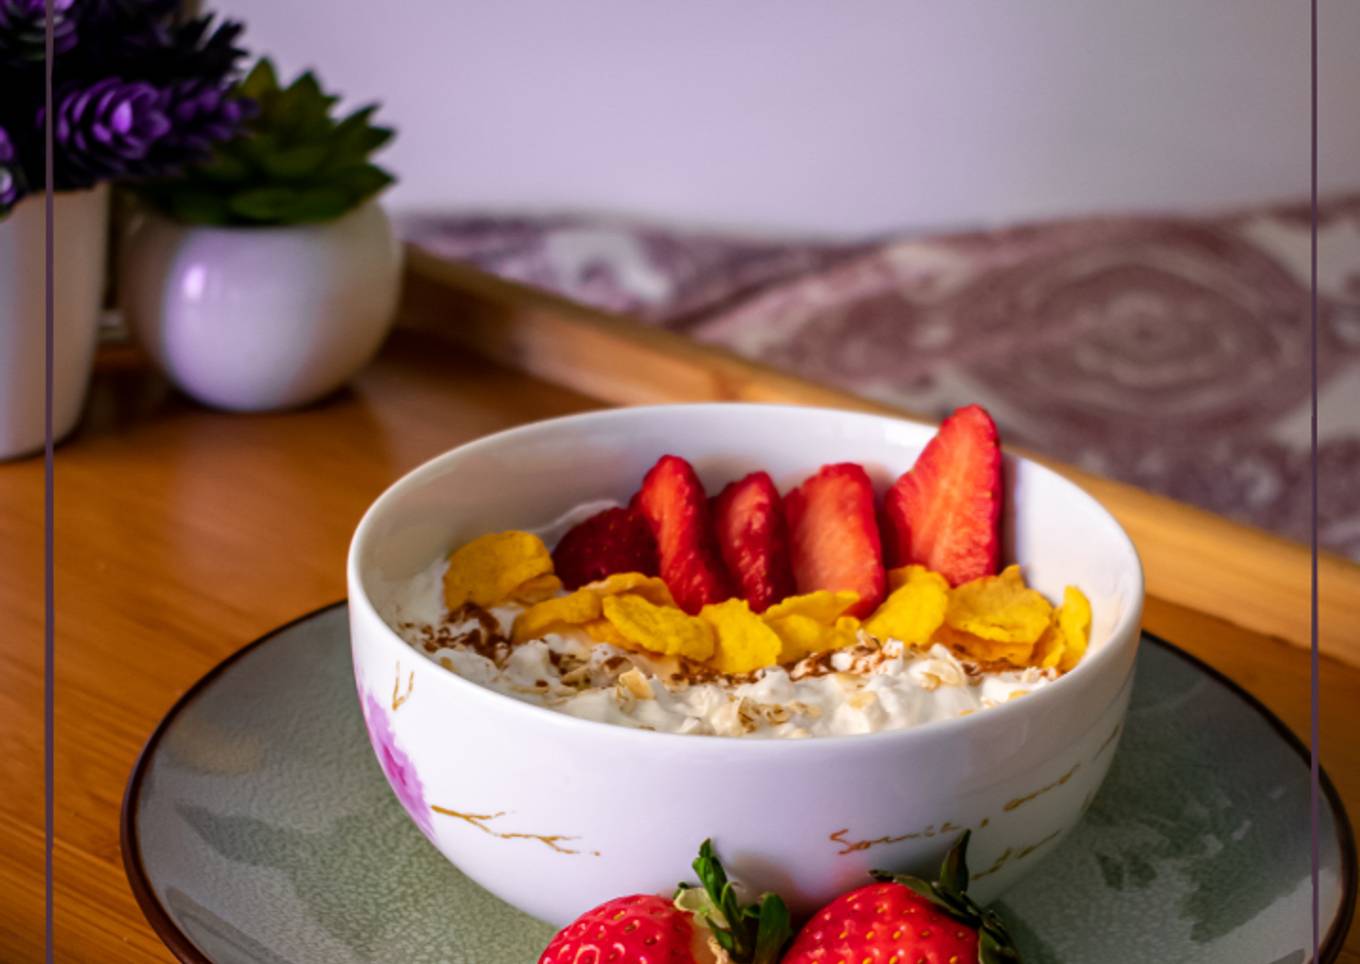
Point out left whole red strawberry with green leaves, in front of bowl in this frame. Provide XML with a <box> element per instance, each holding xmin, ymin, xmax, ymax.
<box><xmin>539</xmin><ymin>840</ymin><xmax>790</xmax><ymax>964</ymax></box>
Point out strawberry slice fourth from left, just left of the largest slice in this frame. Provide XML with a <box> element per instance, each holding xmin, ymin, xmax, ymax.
<box><xmin>783</xmin><ymin>462</ymin><xmax>885</xmax><ymax>617</ymax></box>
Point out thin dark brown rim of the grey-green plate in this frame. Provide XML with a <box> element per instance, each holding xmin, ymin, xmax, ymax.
<box><xmin>118</xmin><ymin>598</ymin><xmax>1360</xmax><ymax>964</ymax></box>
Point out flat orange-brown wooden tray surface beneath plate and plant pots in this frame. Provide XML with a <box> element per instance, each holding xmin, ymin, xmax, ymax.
<box><xmin>0</xmin><ymin>334</ymin><xmax>1360</xmax><ymax>964</ymax></box>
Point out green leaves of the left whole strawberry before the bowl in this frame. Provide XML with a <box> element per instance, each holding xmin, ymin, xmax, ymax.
<box><xmin>676</xmin><ymin>840</ymin><xmax>793</xmax><ymax>964</ymax></box>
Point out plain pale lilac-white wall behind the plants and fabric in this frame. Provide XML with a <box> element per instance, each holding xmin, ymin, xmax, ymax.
<box><xmin>218</xmin><ymin>0</ymin><xmax>1360</xmax><ymax>233</ymax></box>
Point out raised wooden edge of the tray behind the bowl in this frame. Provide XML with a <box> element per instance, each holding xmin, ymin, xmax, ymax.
<box><xmin>403</xmin><ymin>247</ymin><xmax>1360</xmax><ymax>666</ymax></box>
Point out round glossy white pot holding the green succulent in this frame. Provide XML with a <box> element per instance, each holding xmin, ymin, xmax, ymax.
<box><xmin>118</xmin><ymin>201</ymin><xmax>401</xmax><ymax>412</ymax></box>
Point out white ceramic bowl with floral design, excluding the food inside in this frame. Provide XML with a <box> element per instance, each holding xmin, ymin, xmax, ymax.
<box><xmin>348</xmin><ymin>404</ymin><xmax>1142</xmax><ymax>925</ymax></box>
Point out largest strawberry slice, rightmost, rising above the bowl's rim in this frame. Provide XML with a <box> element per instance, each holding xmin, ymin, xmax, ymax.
<box><xmin>883</xmin><ymin>405</ymin><xmax>1001</xmax><ymax>586</ymax></box>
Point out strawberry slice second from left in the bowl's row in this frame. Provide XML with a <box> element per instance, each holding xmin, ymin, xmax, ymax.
<box><xmin>632</xmin><ymin>455</ymin><xmax>733</xmax><ymax>613</ymax></box>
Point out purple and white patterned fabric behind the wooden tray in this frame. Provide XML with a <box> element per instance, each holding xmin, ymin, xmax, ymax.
<box><xmin>399</xmin><ymin>197</ymin><xmax>1360</xmax><ymax>559</ymax></box>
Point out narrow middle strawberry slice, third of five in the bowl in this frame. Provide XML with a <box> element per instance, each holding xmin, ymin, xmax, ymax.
<box><xmin>713</xmin><ymin>472</ymin><xmax>794</xmax><ymax>613</ymax></box>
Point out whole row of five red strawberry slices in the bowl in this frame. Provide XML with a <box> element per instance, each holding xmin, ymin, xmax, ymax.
<box><xmin>552</xmin><ymin>405</ymin><xmax>1001</xmax><ymax>619</ymax></box>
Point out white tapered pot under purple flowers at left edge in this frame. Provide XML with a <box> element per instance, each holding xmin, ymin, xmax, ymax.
<box><xmin>0</xmin><ymin>186</ymin><xmax>109</xmax><ymax>458</ymax></box>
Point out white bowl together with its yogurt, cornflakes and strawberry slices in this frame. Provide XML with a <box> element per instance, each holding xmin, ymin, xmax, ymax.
<box><xmin>348</xmin><ymin>404</ymin><xmax>1142</xmax><ymax>925</ymax></box>
